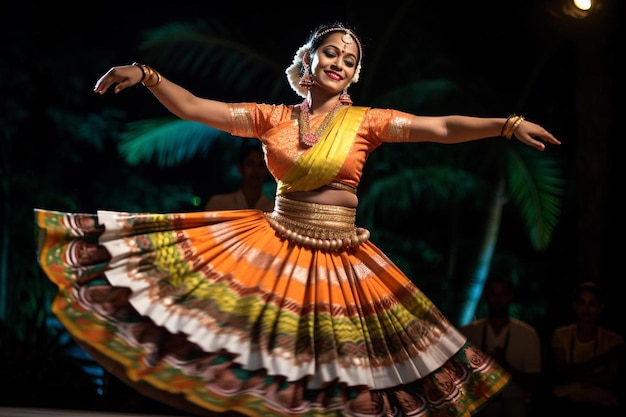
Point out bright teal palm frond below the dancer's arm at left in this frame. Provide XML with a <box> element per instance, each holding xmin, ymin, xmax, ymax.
<box><xmin>119</xmin><ymin>118</ymin><xmax>234</xmax><ymax>167</ymax></box>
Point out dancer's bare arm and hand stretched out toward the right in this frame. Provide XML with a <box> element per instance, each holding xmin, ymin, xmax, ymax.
<box><xmin>410</xmin><ymin>116</ymin><xmax>561</xmax><ymax>151</ymax></box>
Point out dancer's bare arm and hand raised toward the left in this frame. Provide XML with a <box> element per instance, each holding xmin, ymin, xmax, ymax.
<box><xmin>94</xmin><ymin>65</ymin><xmax>232</xmax><ymax>133</ymax></box>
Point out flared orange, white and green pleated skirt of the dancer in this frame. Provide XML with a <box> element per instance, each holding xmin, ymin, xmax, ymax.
<box><xmin>35</xmin><ymin>200</ymin><xmax>509</xmax><ymax>417</ymax></box>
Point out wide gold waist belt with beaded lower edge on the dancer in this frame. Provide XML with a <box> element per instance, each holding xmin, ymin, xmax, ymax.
<box><xmin>265</xmin><ymin>196</ymin><xmax>370</xmax><ymax>250</ymax></box>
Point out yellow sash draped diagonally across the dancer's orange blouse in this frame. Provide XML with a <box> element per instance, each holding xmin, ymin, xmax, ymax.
<box><xmin>276</xmin><ymin>106</ymin><xmax>367</xmax><ymax>195</ymax></box>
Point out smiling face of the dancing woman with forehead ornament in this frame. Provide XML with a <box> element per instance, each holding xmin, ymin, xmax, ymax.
<box><xmin>311</xmin><ymin>32</ymin><xmax>358</xmax><ymax>94</ymax></box>
